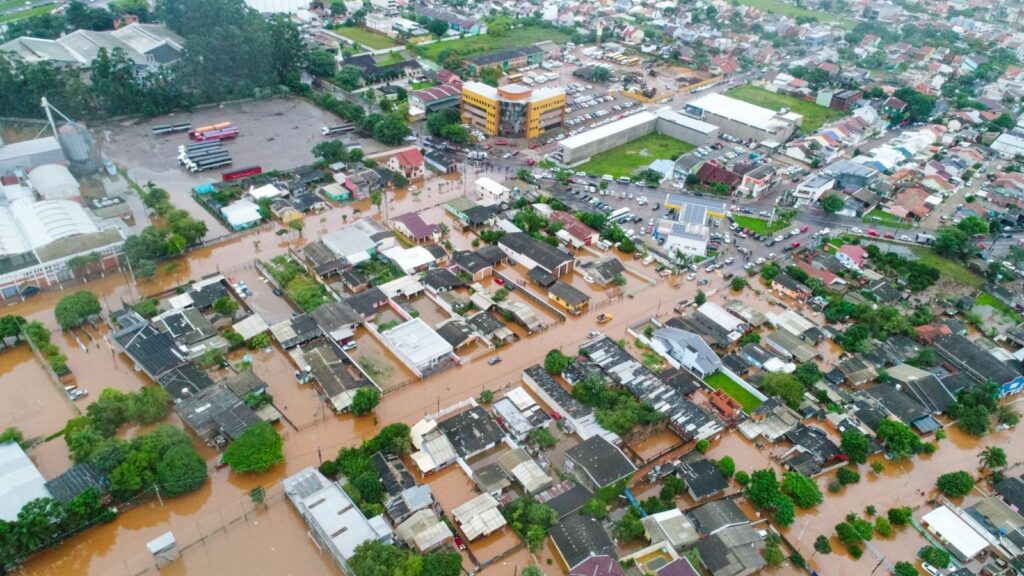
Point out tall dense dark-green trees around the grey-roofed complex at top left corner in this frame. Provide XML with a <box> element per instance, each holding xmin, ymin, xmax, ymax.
<box><xmin>0</xmin><ymin>0</ymin><xmax>305</xmax><ymax>119</ymax></box>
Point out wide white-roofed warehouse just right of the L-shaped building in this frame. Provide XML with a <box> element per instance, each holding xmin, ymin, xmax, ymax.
<box><xmin>683</xmin><ymin>93</ymin><xmax>804</xmax><ymax>143</ymax></box>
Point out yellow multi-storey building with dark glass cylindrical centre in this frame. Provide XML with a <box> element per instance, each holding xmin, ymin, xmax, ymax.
<box><xmin>462</xmin><ymin>82</ymin><xmax>565</xmax><ymax>138</ymax></box>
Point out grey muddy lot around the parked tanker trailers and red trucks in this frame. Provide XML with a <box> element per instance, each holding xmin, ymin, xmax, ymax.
<box><xmin>94</xmin><ymin>98</ymin><xmax>386</xmax><ymax>236</ymax></box>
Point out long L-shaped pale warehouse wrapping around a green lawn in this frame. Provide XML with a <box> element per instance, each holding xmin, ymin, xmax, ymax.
<box><xmin>553</xmin><ymin>107</ymin><xmax>718</xmax><ymax>166</ymax></box>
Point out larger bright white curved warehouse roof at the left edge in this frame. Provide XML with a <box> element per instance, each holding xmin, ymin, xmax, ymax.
<box><xmin>9</xmin><ymin>200</ymin><xmax>99</xmax><ymax>250</ymax></box>
